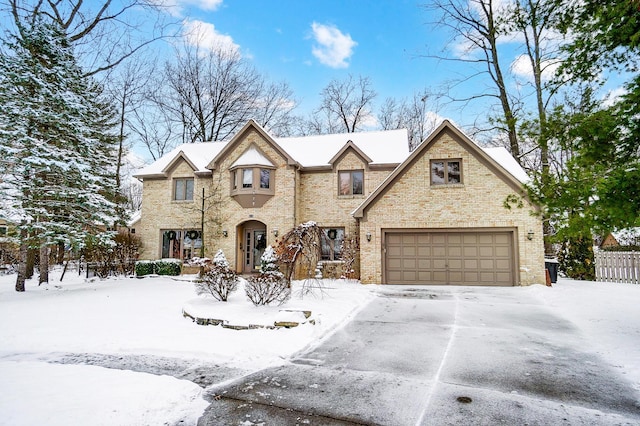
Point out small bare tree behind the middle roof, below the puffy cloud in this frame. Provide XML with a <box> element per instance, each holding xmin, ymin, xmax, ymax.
<box><xmin>313</xmin><ymin>74</ymin><xmax>377</xmax><ymax>133</ymax></box>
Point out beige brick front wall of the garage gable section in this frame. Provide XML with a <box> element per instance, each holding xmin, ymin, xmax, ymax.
<box><xmin>360</xmin><ymin>133</ymin><xmax>545</xmax><ymax>285</ymax></box>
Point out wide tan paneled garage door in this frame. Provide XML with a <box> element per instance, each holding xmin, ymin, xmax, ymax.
<box><xmin>384</xmin><ymin>231</ymin><xmax>515</xmax><ymax>286</ymax></box>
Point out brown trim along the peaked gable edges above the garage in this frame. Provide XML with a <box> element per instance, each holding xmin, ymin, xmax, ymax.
<box><xmin>351</xmin><ymin>120</ymin><xmax>524</xmax><ymax>218</ymax></box>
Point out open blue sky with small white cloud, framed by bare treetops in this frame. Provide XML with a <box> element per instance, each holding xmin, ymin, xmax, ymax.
<box><xmin>162</xmin><ymin>0</ymin><xmax>456</xmax><ymax>120</ymax></box>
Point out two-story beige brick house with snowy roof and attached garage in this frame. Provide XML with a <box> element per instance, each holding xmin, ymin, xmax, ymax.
<box><xmin>135</xmin><ymin>121</ymin><xmax>545</xmax><ymax>285</ymax></box>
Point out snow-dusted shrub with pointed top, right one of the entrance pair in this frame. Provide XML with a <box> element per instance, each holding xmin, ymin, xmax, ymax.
<box><xmin>244</xmin><ymin>246</ymin><xmax>291</xmax><ymax>306</ymax></box>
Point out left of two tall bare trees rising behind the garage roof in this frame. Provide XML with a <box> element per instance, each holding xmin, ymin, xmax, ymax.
<box><xmin>425</xmin><ymin>0</ymin><xmax>521</xmax><ymax>162</ymax></box>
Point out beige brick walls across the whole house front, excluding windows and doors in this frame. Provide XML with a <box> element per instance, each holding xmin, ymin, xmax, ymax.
<box><xmin>136</xmin><ymin>121</ymin><xmax>544</xmax><ymax>285</ymax></box>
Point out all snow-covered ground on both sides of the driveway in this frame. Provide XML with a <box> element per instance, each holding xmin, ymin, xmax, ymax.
<box><xmin>0</xmin><ymin>273</ymin><xmax>640</xmax><ymax>425</ymax></box>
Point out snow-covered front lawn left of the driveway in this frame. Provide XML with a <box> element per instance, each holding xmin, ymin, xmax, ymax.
<box><xmin>0</xmin><ymin>272</ymin><xmax>374</xmax><ymax>425</ymax></box>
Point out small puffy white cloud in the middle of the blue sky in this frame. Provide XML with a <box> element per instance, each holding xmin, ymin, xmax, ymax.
<box><xmin>311</xmin><ymin>22</ymin><xmax>358</xmax><ymax>68</ymax></box>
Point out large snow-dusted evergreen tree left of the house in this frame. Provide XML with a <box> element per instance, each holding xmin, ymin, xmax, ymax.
<box><xmin>0</xmin><ymin>16</ymin><xmax>121</xmax><ymax>287</ymax></box>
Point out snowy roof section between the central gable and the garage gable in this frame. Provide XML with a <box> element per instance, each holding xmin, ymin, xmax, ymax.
<box><xmin>276</xmin><ymin>129</ymin><xmax>409</xmax><ymax>167</ymax></box>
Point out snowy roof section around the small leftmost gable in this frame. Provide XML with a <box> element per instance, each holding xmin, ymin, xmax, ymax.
<box><xmin>133</xmin><ymin>141</ymin><xmax>227</xmax><ymax>178</ymax></box>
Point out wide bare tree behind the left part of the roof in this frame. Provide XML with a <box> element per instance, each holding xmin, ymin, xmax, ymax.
<box><xmin>154</xmin><ymin>42</ymin><xmax>296</xmax><ymax>143</ymax></box>
